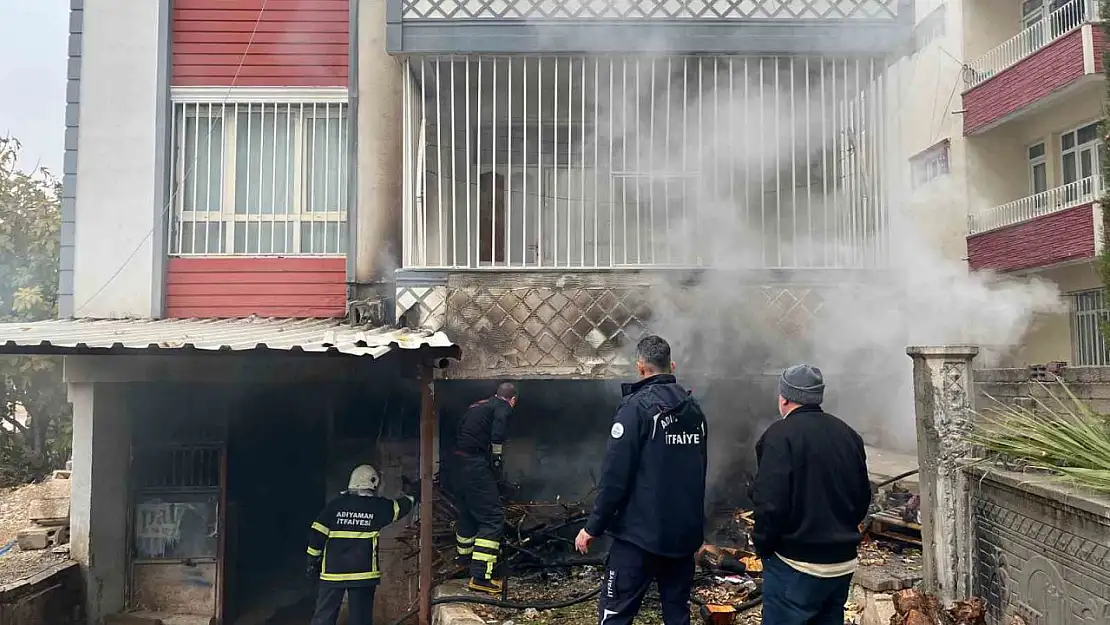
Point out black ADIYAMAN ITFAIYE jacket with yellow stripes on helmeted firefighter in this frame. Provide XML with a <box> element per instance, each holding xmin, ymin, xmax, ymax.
<box><xmin>309</xmin><ymin>493</ymin><xmax>414</xmax><ymax>587</ymax></box>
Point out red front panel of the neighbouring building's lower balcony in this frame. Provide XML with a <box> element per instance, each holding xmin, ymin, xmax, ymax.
<box><xmin>968</xmin><ymin>204</ymin><xmax>1094</xmax><ymax>271</ymax></box>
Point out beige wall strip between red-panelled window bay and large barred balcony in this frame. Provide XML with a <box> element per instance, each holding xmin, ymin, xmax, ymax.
<box><xmin>353</xmin><ymin>0</ymin><xmax>404</xmax><ymax>284</ymax></box>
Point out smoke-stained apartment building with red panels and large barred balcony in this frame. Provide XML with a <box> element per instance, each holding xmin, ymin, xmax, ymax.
<box><xmin>0</xmin><ymin>0</ymin><xmax>914</xmax><ymax>623</ymax></box>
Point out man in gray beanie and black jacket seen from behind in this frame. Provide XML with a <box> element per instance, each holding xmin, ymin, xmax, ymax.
<box><xmin>751</xmin><ymin>364</ymin><xmax>871</xmax><ymax>625</ymax></box>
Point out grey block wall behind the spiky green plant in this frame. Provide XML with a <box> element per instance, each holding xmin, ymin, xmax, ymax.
<box><xmin>975</xmin><ymin>366</ymin><xmax>1110</xmax><ymax>414</ymax></box>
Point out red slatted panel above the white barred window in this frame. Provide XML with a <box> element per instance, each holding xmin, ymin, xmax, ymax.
<box><xmin>173</xmin><ymin>0</ymin><xmax>350</xmax><ymax>87</ymax></box>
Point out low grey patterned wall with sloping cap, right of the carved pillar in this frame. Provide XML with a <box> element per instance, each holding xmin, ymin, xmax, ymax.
<box><xmin>962</xmin><ymin>465</ymin><xmax>1110</xmax><ymax>625</ymax></box>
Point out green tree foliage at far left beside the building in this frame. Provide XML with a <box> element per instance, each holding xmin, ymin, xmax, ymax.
<box><xmin>0</xmin><ymin>137</ymin><xmax>72</xmax><ymax>485</ymax></box>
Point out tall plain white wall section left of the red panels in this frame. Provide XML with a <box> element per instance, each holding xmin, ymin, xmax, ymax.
<box><xmin>71</xmin><ymin>0</ymin><xmax>169</xmax><ymax>317</ymax></box>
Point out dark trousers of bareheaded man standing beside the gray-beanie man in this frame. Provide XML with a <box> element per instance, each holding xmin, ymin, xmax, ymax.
<box><xmin>597</xmin><ymin>540</ymin><xmax>694</xmax><ymax>625</ymax></box>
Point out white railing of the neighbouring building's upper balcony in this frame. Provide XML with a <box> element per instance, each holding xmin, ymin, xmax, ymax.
<box><xmin>963</xmin><ymin>0</ymin><xmax>1099</xmax><ymax>89</ymax></box>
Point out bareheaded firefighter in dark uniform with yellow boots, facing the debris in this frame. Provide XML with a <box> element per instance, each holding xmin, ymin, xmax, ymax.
<box><xmin>454</xmin><ymin>382</ymin><xmax>516</xmax><ymax>594</ymax></box>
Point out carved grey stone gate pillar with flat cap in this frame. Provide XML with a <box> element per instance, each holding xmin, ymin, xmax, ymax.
<box><xmin>906</xmin><ymin>345</ymin><xmax>979</xmax><ymax>603</ymax></box>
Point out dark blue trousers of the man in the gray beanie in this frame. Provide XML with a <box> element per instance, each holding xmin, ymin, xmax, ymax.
<box><xmin>763</xmin><ymin>556</ymin><xmax>851</xmax><ymax>625</ymax></box>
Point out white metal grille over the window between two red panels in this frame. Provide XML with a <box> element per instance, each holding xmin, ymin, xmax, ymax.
<box><xmin>170</xmin><ymin>102</ymin><xmax>349</xmax><ymax>256</ymax></box>
